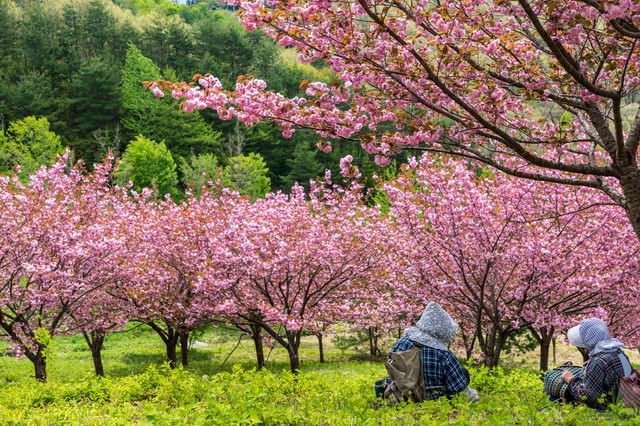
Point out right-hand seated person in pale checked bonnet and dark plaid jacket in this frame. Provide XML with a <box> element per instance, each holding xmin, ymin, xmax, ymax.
<box><xmin>562</xmin><ymin>318</ymin><xmax>632</xmax><ymax>410</ymax></box>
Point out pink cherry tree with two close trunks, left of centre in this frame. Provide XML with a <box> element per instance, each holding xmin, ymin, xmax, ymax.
<box><xmin>115</xmin><ymin>193</ymin><xmax>230</xmax><ymax>368</ymax></box>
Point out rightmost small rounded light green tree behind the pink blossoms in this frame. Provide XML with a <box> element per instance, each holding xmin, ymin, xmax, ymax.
<box><xmin>222</xmin><ymin>152</ymin><xmax>271</xmax><ymax>200</ymax></box>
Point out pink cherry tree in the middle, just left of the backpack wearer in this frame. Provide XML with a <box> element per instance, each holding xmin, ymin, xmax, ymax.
<box><xmin>208</xmin><ymin>181</ymin><xmax>386</xmax><ymax>372</ymax></box>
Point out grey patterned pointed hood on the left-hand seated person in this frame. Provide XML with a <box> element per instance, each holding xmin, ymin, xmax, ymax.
<box><xmin>405</xmin><ymin>302</ymin><xmax>458</xmax><ymax>351</ymax></box>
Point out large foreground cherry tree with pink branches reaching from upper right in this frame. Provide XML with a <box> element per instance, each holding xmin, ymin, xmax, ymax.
<box><xmin>150</xmin><ymin>0</ymin><xmax>640</xmax><ymax>243</ymax></box>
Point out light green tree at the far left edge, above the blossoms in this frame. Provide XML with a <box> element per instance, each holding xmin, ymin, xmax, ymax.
<box><xmin>0</xmin><ymin>116</ymin><xmax>63</xmax><ymax>179</ymax></box>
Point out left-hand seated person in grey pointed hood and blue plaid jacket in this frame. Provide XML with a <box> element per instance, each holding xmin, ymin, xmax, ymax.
<box><xmin>391</xmin><ymin>302</ymin><xmax>478</xmax><ymax>401</ymax></box>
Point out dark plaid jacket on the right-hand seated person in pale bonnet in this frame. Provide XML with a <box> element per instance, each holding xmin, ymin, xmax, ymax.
<box><xmin>569</xmin><ymin>351</ymin><xmax>624</xmax><ymax>409</ymax></box>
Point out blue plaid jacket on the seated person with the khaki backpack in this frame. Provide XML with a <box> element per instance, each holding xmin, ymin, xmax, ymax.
<box><xmin>391</xmin><ymin>336</ymin><xmax>469</xmax><ymax>399</ymax></box>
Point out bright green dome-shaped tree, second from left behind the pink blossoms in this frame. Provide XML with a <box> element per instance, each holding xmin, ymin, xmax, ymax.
<box><xmin>114</xmin><ymin>135</ymin><xmax>178</xmax><ymax>197</ymax></box>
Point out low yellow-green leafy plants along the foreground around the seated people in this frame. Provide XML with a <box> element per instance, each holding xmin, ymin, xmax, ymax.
<box><xmin>0</xmin><ymin>362</ymin><xmax>640</xmax><ymax>425</ymax></box>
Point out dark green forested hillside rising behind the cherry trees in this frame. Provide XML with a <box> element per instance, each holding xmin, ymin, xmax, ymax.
<box><xmin>0</xmin><ymin>0</ymin><xmax>358</xmax><ymax>191</ymax></box>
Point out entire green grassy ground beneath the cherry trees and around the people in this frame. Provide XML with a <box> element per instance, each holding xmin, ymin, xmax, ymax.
<box><xmin>0</xmin><ymin>328</ymin><xmax>640</xmax><ymax>425</ymax></box>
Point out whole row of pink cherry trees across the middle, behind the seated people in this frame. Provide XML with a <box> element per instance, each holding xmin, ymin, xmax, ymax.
<box><xmin>0</xmin><ymin>157</ymin><xmax>640</xmax><ymax>381</ymax></box>
